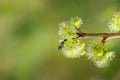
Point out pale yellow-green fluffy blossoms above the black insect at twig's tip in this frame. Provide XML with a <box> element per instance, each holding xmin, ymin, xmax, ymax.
<box><xmin>58</xmin><ymin>16</ymin><xmax>83</xmax><ymax>39</ymax></box>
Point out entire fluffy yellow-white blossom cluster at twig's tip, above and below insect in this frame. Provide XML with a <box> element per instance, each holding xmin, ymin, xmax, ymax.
<box><xmin>58</xmin><ymin>16</ymin><xmax>86</xmax><ymax>58</ymax></box>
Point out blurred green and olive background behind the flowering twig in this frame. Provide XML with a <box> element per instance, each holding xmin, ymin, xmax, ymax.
<box><xmin>0</xmin><ymin>0</ymin><xmax>120</xmax><ymax>80</ymax></box>
